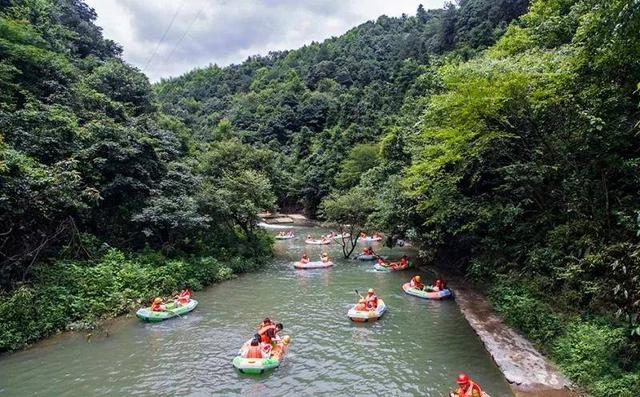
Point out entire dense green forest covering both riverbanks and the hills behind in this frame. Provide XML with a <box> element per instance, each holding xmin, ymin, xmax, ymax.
<box><xmin>0</xmin><ymin>0</ymin><xmax>640</xmax><ymax>396</ymax></box>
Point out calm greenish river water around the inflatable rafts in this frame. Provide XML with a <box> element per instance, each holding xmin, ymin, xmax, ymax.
<box><xmin>0</xmin><ymin>227</ymin><xmax>513</xmax><ymax>397</ymax></box>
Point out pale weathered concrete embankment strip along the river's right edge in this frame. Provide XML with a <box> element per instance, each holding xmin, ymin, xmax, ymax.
<box><xmin>445</xmin><ymin>273</ymin><xmax>578</xmax><ymax>397</ymax></box>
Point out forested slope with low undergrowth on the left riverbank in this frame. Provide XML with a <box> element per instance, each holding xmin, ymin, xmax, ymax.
<box><xmin>0</xmin><ymin>0</ymin><xmax>278</xmax><ymax>351</ymax></box>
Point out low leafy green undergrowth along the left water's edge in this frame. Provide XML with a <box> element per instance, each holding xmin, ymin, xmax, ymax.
<box><xmin>0</xmin><ymin>243</ymin><xmax>269</xmax><ymax>352</ymax></box>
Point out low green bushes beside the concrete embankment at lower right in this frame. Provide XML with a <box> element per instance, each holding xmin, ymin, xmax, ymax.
<box><xmin>489</xmin><ymin>276</ymin><xmax>640</xmax><ymax>397</ymax></box>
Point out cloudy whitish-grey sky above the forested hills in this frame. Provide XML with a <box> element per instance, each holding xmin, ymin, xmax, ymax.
<box><xmin>85</xmin><ymin>0</ymin><xmax>444</xmax><ymax>81</ymax></box>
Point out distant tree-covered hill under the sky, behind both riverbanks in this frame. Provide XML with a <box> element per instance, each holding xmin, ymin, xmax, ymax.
<box><xmin>155</xmin><ymin>0</ymin><xmax>527</xmax><ymax>214</ymax></box>
